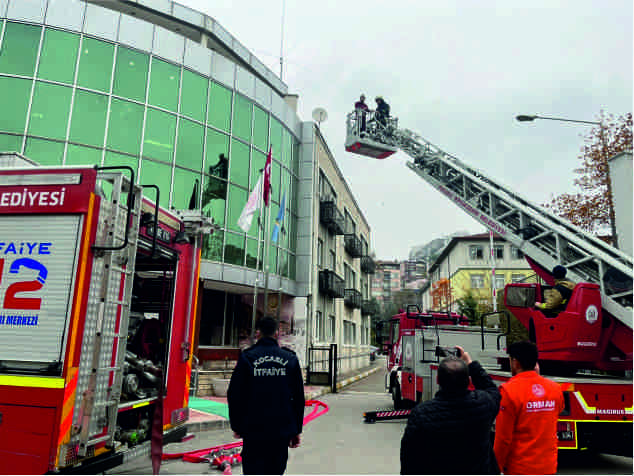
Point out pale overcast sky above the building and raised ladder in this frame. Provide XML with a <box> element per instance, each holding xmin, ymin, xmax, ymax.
<box><xmin>179</xmin><ymin>0</ymin><xmax>633</xmax><ymax>259</ymax></box>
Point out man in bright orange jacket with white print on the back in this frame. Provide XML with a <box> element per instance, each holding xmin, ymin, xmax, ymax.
<box><xmin>493</xmin><ymin>341</ymin><xmax>564</xmax><ymax>474</ymax></box>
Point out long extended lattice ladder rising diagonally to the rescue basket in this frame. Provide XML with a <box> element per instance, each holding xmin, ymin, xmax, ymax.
<box><xmin>368</xmin><ymin>124</ymin><xmax>633</xmax><ymax>329</ymax></box>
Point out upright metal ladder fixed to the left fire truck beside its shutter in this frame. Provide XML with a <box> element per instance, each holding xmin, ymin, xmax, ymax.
<box><xmin>71</xmin><ymin>171</ymin><xmax>142</xmax><ymax>457</ymax></box>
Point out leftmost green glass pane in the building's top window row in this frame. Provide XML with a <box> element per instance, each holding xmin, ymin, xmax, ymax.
<box><xmin>0</xmin><ymin>22</ymin><xmax>42</xmax><ymax>76</ymax></box>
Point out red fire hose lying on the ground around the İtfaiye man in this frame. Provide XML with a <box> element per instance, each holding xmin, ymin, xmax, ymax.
<box><xmin>162</xmin><ymin>400</ymin><xmax>329</xmax><ymax>474</ymax></box>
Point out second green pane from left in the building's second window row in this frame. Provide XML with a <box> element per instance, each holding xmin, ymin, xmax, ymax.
<box><xmin>29</xmin><ymin>81</ymin><xmax>73</xmax><ymax>140</ymax></box>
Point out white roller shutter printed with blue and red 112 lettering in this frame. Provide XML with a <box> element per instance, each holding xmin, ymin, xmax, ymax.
<box><xmin>0</xmin><ymin>214</ymin><xmax>82</xmax><ymax>374</ymax></box>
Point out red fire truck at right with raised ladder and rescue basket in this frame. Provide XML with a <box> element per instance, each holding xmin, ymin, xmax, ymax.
<box><xmin>346</xmin><ymin>112</ymin><xmax>634</xmax><ymax>455</ymax></box>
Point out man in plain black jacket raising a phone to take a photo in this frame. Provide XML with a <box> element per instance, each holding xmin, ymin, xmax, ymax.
<box><xmin>401</xmin><ymin>346</ymin><xmax>500</xmax><ymax>474</ymax></box>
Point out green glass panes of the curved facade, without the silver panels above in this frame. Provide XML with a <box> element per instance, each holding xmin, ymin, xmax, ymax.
<box><xmin>0</xmin><ymin>19</ymin><xmax>299</xmax><ymax>279</ymax></box>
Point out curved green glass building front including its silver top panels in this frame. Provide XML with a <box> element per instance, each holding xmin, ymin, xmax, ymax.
<box><xmin>0</xmin><ymin>0</ymin><xmax>299</xmax><ymax>279</ymax></box>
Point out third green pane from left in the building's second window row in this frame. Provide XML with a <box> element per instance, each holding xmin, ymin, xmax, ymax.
<box><xmin>70</xmin><ymin>91</ymin><xmax>108</xmax><ymax>147</ymax></box>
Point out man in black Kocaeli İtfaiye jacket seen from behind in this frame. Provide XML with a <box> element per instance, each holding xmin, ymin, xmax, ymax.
<box><xmin>227</xmin><ymin>316</ymin><xmax>304</xmax><ymax>474</ymax></box>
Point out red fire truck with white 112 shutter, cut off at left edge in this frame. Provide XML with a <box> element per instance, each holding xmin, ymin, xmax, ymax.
<box><xmin>0</xmin><ymin>155</ymin><xmax>209</xmax><ymax>474</ymax></box>
